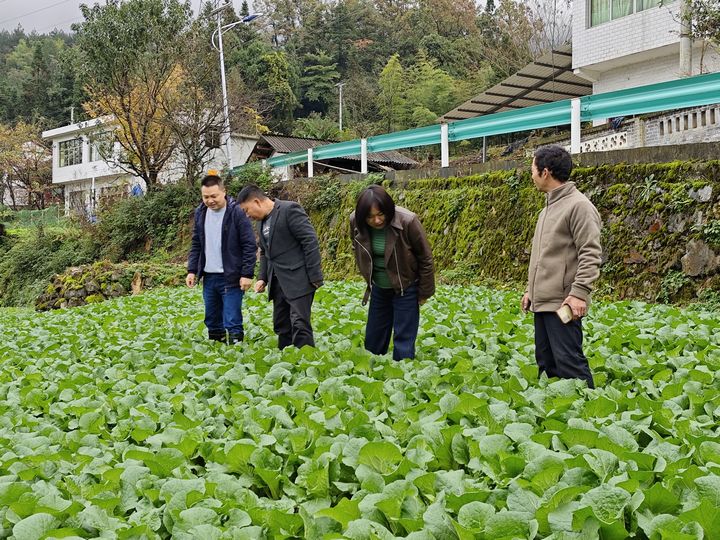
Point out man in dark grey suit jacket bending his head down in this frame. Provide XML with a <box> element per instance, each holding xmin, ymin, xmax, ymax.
<box><xmin>237</xmin><ymin>185</ymin><xmax>323</xmax><ymax>349</ymax></box>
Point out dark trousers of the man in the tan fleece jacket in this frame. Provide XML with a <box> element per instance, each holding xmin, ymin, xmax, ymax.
<box><xmin>535</xmin><ymin>311</ymin><xmax>595</xmax><ymax>388</ymax></box>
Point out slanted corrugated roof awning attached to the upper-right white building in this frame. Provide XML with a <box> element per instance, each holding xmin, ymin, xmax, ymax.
<box><xmin>440</xmin><ymin>44</ymin><xmax>593</xmax><ymax>122</ymax></box>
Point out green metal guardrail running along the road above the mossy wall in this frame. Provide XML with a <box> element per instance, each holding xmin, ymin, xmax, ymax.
<box><xmin>258</xmin><ymin>72</ymin><xmax>720</xmax><ymax>173</ymax></box>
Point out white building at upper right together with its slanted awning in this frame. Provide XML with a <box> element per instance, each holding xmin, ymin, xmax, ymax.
<box><xmin>442</xmin><ymin>0</ymin><xmax>720</xmax><ymax>152</ymax></box>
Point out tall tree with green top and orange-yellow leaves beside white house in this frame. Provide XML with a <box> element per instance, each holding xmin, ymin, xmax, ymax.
<box><xmin>75</xmin><ymin>0</ymin><xmax>192</xmax><ymax>189</ymax></box>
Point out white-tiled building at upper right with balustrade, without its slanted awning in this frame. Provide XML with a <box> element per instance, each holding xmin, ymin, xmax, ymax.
<box><xmin>572</xmin><ymin>0</ymin><xmax>720</xmax><ymax>146</ymax></box>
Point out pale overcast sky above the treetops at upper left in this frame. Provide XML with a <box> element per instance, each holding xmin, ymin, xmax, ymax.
<box><xmin>0</xmin><ymin>0</ymin><xmax>251</xmax><ymax>34</ymax></box>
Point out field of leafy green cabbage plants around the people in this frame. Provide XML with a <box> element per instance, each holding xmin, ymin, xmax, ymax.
<box><xmin>0</xmin><ymin>283</ymin><xmax>720</xmax><ymax>540</ymax></box>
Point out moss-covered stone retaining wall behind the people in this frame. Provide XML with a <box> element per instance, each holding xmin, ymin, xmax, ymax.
<box><xmin>276</xmin><ymin>161</ymin><xmax>720</xmax><ymax>301</ymax></box>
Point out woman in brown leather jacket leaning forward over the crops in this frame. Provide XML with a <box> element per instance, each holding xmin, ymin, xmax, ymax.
<box><xmin>350</xmin><ymin>186</ymin><xmax>435</xmax><ymax>360</ymax></box>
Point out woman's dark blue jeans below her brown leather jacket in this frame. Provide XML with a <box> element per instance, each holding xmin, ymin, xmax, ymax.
<box><xmin>365</xmin><ymin>285</ymin><xmax>420</xmax><ymax>360</ymax></box>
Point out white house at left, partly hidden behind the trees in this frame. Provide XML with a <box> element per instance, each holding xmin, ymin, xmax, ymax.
<box><xmin>42</xmin><ymin>119</ymin><xmax>258</xmax><ymax>216</ymax></box>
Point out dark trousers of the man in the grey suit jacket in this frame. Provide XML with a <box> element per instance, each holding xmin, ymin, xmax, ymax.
<box><xmin>271</xmin><ymin>277</ymin><xmax>315</xmax><ymax>349</ymax></box>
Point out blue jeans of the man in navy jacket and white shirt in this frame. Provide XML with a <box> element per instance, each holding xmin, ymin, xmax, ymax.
<box><xmin>203</xmin><ymin>274</ymin><xmax>244</xmax><ymax>336</ymax></box>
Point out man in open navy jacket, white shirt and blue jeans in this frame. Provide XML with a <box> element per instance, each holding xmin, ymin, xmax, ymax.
<box><xmin>185</xmin><ymin>174</ymin><xmax>257</xmax><ymax>344</ymax></box>
